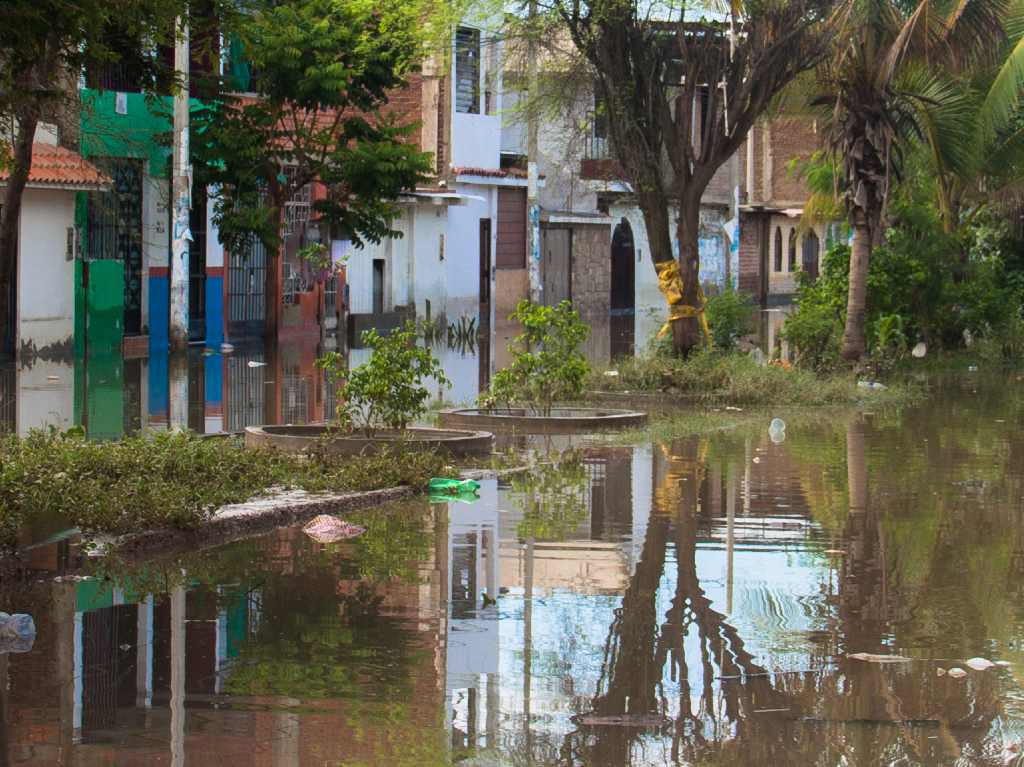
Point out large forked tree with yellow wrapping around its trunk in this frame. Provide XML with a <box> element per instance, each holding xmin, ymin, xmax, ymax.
<box><xmin>548</xmin><ymin>0</ymin><xmax>834</xmax><ymax>353</ymax></box>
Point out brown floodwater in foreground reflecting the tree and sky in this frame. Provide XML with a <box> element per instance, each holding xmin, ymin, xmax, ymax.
<box><xmin>0</xmin><ymin>368</ymin><xmax>1024</xmax><ymax>767</ymax></box>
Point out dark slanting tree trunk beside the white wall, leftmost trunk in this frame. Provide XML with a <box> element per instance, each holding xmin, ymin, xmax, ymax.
<box><xmin>0</xmin><ymin>112</ymin><xmax>39</xmax><ymax>354</ymax></box>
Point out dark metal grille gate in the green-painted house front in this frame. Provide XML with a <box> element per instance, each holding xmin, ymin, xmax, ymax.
<box><xmin>85</xmin><ymin>158</ymin><xmax>142</xmax><ymax>336</ymax></box>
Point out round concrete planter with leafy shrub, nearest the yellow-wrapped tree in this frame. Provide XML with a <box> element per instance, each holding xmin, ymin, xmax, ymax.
<box><xmin>439</xmin><ymin>300</ymin><xmax>647</xmax><ymax>434</ymax></box>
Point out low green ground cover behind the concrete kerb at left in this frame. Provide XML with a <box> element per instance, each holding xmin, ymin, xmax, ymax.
<box><xmin>0</xmin><ymin>431</ymin><xmax>456</xmax><ymax>549</ymax></box>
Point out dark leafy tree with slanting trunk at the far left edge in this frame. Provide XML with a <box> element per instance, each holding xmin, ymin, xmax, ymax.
<box><xmin>0</xmin><ymin>0</ymin><xmax>189</xmax><ymax>350</ymax></box>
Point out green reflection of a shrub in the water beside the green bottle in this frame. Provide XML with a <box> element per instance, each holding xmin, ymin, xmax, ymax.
<box><xmin>512</xmin><ymin>451</ymin><xmax>589</xmax><ymax>541</ymax></box>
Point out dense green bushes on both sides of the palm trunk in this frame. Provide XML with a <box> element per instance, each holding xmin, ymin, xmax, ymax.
<box><xmin>783</xmin><ymin>181</ymin><xmax>1024</xmax><ymax>371</ymax></box>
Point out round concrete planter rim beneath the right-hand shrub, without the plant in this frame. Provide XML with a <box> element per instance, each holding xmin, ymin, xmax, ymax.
<box><xmin>437</xmin><ymin>408</ymin><xmax>647</xmax><ymax>434</ymax></box>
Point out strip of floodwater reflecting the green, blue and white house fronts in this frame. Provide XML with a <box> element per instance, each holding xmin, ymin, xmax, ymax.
<box><xmin>0</xmin><ymin>339</ymin><xmax>481</xmax><ymax>439</ymax></box>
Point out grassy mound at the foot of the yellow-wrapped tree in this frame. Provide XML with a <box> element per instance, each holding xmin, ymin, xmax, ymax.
<box><xmin>591</xmin><ymin>351</ymin><xmax>918</xmax><ymax>407</ymax></box>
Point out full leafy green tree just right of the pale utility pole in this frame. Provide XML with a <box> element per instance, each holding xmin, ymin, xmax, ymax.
<box><xmin>194</xmin><ymin>0</ymin><xmax>431</xmax><ymax>332</ymax></box>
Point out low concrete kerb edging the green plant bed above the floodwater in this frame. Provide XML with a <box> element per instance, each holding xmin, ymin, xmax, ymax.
<box><xmin>90</xmin><ymin>486</ymin><xmax>417</xmax><ymax>561</ymax></box>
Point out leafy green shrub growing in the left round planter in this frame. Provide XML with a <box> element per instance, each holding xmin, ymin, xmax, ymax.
<box><xmin>316</xmin><ymin>323</ymin><xmax>451</xmax><ymax>437</ymax></box>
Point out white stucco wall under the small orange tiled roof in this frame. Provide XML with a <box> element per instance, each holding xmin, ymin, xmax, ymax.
<box><xmin>17</xmin><ymin>188</ymin><xmax>75</xmax><ymax>349</ymax></box>
